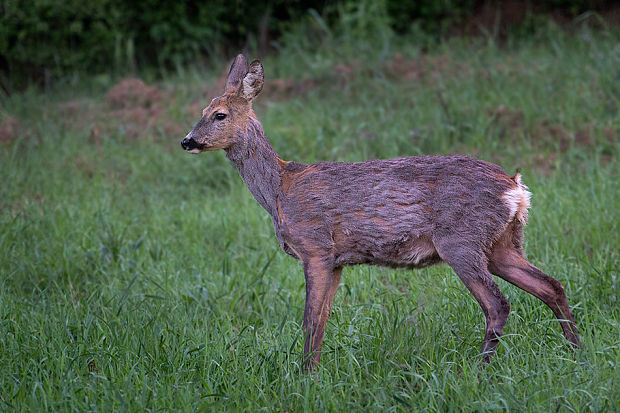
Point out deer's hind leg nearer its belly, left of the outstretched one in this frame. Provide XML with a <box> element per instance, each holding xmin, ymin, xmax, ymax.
<box><xmin>437</xmin><ymin>246</ymin><xmax>510</xmax><ymax>363</ymax></box>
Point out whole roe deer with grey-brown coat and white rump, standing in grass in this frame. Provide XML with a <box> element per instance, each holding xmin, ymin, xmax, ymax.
<box><xmin>181</xmin><ymin>55</ymin><xmax>581</xmax><ymax>371</ymax></box>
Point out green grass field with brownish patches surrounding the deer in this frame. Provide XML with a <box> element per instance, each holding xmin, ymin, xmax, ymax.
<box><xmin>0</xmin><ymin>21</ymin><xmax>620</xmax><ymax>412</ymax></box>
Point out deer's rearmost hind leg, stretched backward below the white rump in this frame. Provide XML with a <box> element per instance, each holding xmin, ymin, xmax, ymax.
<box><xmin>489</xmin><ymin>244</ymin><xmax>581</xmax><ymax>347</ymax></box>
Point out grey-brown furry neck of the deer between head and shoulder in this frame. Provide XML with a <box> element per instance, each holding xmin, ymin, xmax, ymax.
<box><xmin>226</xmin><ymin>118</ymin><xmax>282</xmax><ymax>217</ymax></box>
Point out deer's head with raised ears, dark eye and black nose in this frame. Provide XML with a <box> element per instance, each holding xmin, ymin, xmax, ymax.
<box><xmin>181</xmin><ymin>54</ymin><xmax>264</xmax><ymax>153</ymax></box>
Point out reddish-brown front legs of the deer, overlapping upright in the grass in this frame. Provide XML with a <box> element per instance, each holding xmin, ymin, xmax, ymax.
<box><xmin>303</xmin><ymin>257</ymin><xmax>340</xmax><ymax>372</ymax></box>
